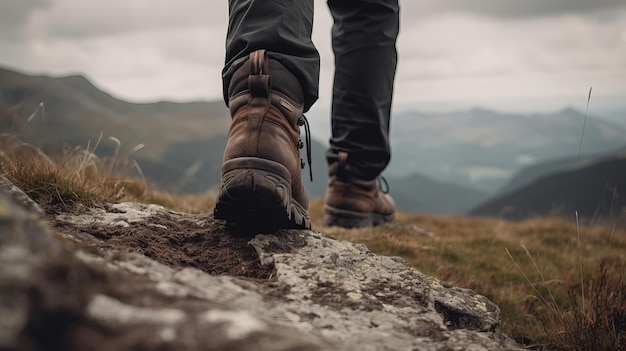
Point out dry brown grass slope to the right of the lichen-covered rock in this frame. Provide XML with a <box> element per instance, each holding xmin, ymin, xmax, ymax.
<box><xmin>311</xmin><ymin>200</ymin><xmax>626</xmax><ymax>350</ymax></box>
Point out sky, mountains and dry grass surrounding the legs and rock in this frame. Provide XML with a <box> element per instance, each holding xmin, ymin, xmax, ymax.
<box><xmin>0</xmin><ymin>0</ymin><xmax>626</xmax><ymax>350</ymax></box>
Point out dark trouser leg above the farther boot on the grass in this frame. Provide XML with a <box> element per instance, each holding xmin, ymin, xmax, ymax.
<box><xmin>327</xmin><ymin>0</ymin><xmax>399</xmax><ymax>179</ymax></box>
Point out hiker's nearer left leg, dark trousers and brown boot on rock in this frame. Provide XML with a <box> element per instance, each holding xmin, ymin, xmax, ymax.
<box><xmin>214</xmin><ymin>0</ymin><xmax>319</xmax><ymax>230</ymax></box>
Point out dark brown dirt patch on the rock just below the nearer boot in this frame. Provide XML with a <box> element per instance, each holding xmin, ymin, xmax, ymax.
<box><xmin>56</xmin><ymin>215</ymin><xmax>274</xmax><ymax>280</ymax></box>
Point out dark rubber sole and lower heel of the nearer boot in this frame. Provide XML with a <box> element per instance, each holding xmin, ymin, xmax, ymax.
<box><xmin>214</xmin><ymin>157</ymin><xmax>311</xmax><ymax>231</ymax></box>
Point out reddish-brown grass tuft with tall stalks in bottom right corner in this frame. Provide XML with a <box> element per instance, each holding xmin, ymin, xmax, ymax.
<box><xmin>506</xmin><ymin>221</ymin><xmax>626</xmax><ymax>351</ymax></box>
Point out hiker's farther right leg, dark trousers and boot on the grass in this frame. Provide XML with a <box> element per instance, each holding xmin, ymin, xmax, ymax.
<box><xmin>324</xmin><ymin>0</ymin><xmax>399</xmax><ymax>228</ymax></box>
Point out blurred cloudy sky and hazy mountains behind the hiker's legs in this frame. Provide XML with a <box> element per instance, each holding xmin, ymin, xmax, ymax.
<box><xmin>0</xmin><ymin>0</ymin><xmax>626</xmax><ymax>219</ymax></box>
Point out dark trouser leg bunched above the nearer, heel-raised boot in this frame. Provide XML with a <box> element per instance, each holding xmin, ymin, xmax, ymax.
<box><xmin>222</xmin><ymin>0</ymin><xmax>320</xmax><ymax>111</ymax></box>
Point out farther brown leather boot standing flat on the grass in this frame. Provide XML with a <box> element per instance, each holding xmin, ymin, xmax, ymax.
<box><xmin>324</xmin><ymin>152</ymin><xmax>396</xmax><ymax>228</ymax></box>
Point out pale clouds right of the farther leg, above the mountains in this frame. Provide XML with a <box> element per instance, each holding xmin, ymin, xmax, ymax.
<box><xmin>395</xmin><ymin>2</ymin><xmax>626</xmax><ymax>111</ymax></box>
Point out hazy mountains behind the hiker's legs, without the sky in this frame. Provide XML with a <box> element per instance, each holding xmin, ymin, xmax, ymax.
<box><xmin>0</xmin><ymin>70</ymin><xmax>626</xmax><ymax>223</ymax></box>
